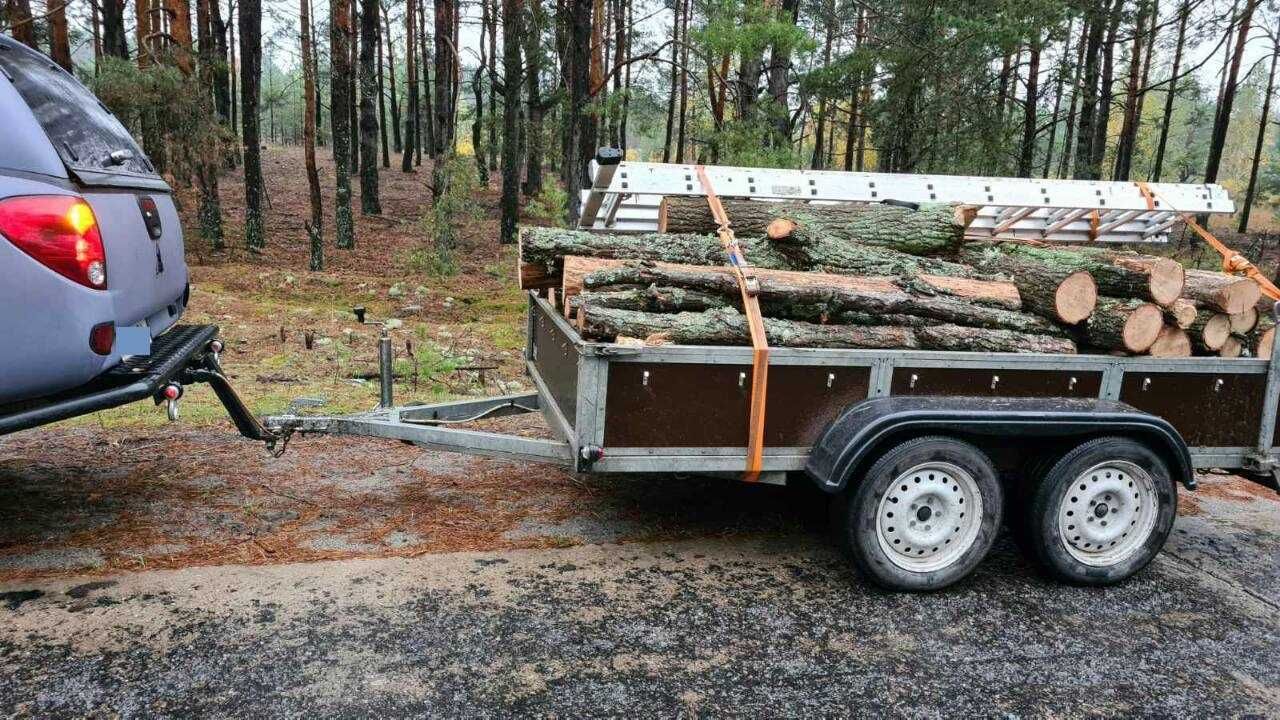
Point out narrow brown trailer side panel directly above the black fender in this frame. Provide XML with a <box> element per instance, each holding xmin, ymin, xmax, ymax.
<box><xmin>891</xmin><ymin>368</ymin><xmax>1102</xmax><ymax>397</ymax></box>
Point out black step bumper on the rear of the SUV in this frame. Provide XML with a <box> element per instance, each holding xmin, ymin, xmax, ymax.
<box><xmin>0</xmin><ymin>325</ymin><xmax>218</xmax><ymax>436</ymax></box>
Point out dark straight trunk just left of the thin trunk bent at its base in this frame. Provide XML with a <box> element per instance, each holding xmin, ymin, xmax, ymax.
<box><xmin>237</xmin><ymin>0</ymin><xmax>266</xmax><ymax>251</ymax></box>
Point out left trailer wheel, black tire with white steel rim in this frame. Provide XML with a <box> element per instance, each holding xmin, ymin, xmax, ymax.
<box><xmin>837</xmin><ymin>436</ymin><xmax>1004</xmax><ymax>591</ymax></box>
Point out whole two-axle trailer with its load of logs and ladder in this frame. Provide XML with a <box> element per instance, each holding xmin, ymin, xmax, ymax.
<box><xmin>249</xmin><ymin>154</ymin><xmax>1280</xmax><ymax>591</ymax></box>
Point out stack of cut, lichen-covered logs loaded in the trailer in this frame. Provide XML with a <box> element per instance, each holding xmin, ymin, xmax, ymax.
<box><xmin>520</xmin><ymin>197</ymin><xmax>1275</xmax><ymax>357</ymax></box>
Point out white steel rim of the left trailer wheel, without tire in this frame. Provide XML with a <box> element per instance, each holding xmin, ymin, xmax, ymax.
<box><xmin>876</xmin><ymin>461</ymin><xmax>983</xmax><ymax>573</ymax></box>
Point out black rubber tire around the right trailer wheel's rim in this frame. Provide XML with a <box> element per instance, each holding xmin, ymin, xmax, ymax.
<box><xmin>1029</xmin><ymin>437</ymin><xmax>1178</xmax><ymax>585</ymax></box>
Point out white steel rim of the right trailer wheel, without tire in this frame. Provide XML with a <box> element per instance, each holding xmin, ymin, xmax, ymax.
<box><xmin>1057</xmin><ymin>460</ymin><xmax>1160</xmax><ymax>568</ymax></box>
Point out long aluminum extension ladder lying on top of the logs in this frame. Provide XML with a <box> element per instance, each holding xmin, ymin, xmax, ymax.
<box><xmin>579</xmin><ymin>149</ymin><xmax>1235</xmax><ymax>242</ymax></box>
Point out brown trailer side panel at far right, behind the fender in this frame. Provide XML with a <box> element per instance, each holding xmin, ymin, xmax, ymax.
<box><xmin>1120</xmin><ymin>373</ymin><xmax>1267</xmax><ymax>447</ymax></box>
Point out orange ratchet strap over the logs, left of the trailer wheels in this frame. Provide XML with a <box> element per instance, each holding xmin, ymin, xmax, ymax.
<box><xmin>696</xmin><ymin>165</ymin><xmax>769</xmax><ymax>483</ymax></box>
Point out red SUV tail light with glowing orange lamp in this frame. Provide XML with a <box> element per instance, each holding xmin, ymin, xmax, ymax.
<box><xmin>0</xmin><ymin>195</ymin><xmax>106</xmax><ymax>290</ymax></box>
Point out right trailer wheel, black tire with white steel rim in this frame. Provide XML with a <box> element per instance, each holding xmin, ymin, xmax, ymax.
<box><xmin>1029</xmin><ymin>437</ymin><xmax>1178</xmax><ymax>585</ymax></box>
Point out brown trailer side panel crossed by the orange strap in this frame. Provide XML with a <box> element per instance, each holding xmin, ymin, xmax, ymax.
<box><xmin>604</xmin><ymin>363</ymin><xmax>870</xmax><ymax>447</ymax></box>
